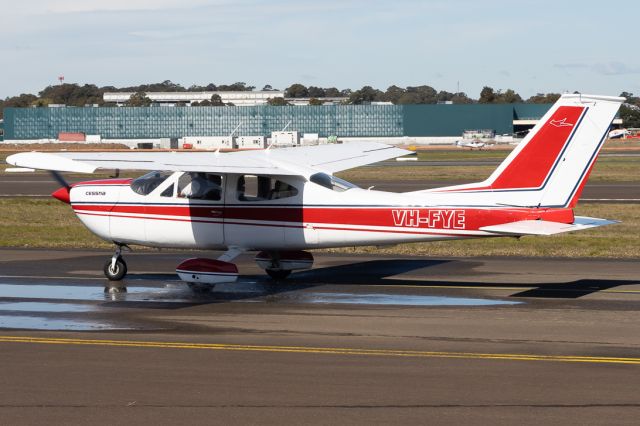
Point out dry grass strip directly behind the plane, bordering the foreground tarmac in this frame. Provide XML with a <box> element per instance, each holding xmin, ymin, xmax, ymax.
<box><xmin>0</xmin><ymin>198</ymin><xmax>640</xmax><ymax>258</ymax></box>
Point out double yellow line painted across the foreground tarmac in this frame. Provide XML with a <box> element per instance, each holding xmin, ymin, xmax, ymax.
<box><xmin>0</xmin><ymin>336</ymin><xmax>640</xmax><ymax>365</ymax></box>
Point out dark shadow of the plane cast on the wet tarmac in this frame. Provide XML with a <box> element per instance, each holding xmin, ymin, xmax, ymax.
<box><xmin>106</xmin><ymin>259</ymin><xmax>639</xmax><ymax>309</ymax></box>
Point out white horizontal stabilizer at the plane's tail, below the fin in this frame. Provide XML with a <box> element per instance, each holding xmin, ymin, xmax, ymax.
<box><xmin>480</xmin><ymin>216</ymin><xmax>617</xmax><ymax>236</ymax></box>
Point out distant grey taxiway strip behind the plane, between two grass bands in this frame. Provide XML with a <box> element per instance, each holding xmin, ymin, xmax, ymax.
<box><xmin>0</xmin><ymin>172</ymin><xmax>640</xmax><ymax>203</ymax></box>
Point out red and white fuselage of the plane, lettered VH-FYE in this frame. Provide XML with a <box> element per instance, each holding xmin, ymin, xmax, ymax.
<box><xmin>70</xmin><ymin>172</ymin><xmax>573</xmax><ymax>250</ymax></box>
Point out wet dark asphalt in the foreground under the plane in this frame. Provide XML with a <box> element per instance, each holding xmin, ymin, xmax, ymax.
<box><xmin>0</xmin><ymin>249</ymin><xmax>640</xmax><ymax>425</ymax></box>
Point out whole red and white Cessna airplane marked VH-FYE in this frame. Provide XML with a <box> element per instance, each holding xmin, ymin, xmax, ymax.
<box><xmin>7</xmin><ymin>94</ymin><xmax>624</xmax><ymax>284</ymax></box>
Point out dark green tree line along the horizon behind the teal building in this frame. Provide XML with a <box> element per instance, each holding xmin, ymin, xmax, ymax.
<box><xmin>0</xmin><ymin>80</ymin><xmax>640</xmax><ymax>127</ymax></box>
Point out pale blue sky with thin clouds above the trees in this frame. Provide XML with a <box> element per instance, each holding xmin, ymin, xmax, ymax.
<box><xmin>0</xmin><ymin>0</ymin><xmax>640</xmax><ymax>98</ymax></box>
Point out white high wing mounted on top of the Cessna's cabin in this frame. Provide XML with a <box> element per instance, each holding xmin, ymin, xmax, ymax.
<box><xmin>7</xmin><ymin>142</ymin><xmax>411</xmax><ymax>176</ymax></box>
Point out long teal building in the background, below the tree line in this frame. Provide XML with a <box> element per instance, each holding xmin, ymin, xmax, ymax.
<box><xmin>4</xmin><ymin>103</ymin><xmax>551</xmax><ymax>143</ymax></box>
